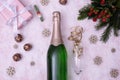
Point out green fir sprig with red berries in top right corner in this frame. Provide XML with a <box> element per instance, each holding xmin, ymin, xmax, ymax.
<box><xmin>78</xmin><ymin>0</ymin><xmax>120</xmax><ymax>42</ymax></box>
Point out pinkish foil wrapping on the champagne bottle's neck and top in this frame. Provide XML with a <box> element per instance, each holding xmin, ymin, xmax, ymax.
<box><xmin>51</xmin><ymin>11</ymin><xmax>63</xmax><ymax>46</ymax></box>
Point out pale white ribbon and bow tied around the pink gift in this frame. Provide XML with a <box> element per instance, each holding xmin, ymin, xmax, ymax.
<box><xmin>0</xmin><ymin>0</ymin><xmax>32</xmax><ymax>35</ymax></box>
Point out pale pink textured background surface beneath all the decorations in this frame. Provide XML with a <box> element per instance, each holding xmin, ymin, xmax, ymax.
<box><xmin>0</xmin><ymin>0</ymin><xmax>120</xmax><ymax>80</ymax></box>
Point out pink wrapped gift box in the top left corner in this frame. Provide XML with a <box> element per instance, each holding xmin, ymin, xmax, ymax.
<box><xmin>0</xmin><ymin>0</ymin><xmax>32</xmax><ymax>28</ymax></box>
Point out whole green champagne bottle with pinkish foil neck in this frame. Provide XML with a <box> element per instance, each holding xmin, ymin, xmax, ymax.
<box><xmin>47</xmin><ymin>11</ymin><xmax>67</xmax><ymax>80</ymax></box>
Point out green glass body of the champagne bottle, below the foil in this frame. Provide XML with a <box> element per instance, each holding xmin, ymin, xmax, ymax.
<box><xmin>47</xmin><ymin>44</ymin><xmax>67</xmax><ymax>80</ymax></box>
